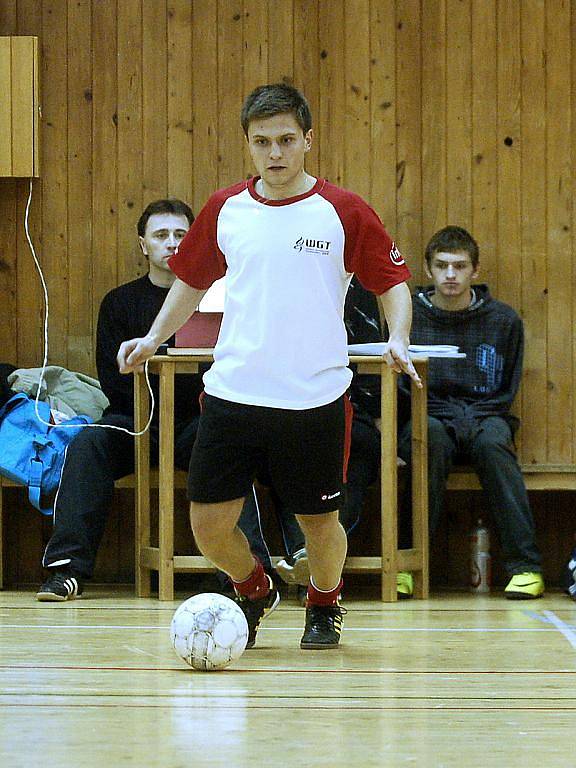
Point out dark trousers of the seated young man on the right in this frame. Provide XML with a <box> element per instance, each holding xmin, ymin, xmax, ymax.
<box><xmin>398</xmin><ymin>416</ymin><xmax>542</xmax><ymax>575</ymax></box>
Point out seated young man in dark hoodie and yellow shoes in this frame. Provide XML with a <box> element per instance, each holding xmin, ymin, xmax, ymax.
<box><xmin>398</xmin><ymin>226</ymin><xmax>544</xmax><ymax>600</ymax></box>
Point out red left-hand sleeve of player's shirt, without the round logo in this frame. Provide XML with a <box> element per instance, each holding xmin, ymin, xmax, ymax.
<box><xmin>168</xmin><ymin>182</ymin><xmax>246</xmax><ymax>290</ymax></box>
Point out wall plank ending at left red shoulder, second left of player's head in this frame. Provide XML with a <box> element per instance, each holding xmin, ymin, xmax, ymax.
<box><xmin>192</xmin><ymin>0</ymin><xmax>218</xmax><ymax>214</ymax></box>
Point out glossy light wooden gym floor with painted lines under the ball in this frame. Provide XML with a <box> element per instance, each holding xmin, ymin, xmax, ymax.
<box><xmin>0</xmin><ymin>587</ymin><xmax>576</xmax><ymax>768</ymax></box>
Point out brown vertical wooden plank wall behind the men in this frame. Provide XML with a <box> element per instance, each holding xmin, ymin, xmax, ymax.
<box><xmin>0</xmin><ymin>0</ymin><xmax>576</xmax><ymax>500</ymax></box>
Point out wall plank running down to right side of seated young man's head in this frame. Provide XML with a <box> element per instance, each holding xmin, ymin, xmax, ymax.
<box><xmin>471</xmin><ymin>0</ymin><xmax>500</xmax><ymax>290</ymax></box>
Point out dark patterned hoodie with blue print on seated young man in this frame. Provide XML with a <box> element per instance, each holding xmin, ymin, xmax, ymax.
<box><xmin>400</xmin><ymin>285</ymin><xmax>524</xmax><ymax>430</ymax></box>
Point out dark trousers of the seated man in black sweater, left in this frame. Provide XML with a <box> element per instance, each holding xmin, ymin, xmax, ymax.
<box><xmin>42</xmin><ymin>414</ymin><xmax>198</xmax><ymax>579</ymax></box>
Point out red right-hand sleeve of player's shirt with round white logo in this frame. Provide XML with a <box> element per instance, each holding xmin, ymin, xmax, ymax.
<box><xmin>322</xmin><ymin>184</ymin><xmax>411</xmax><ymax>296</ymax></box>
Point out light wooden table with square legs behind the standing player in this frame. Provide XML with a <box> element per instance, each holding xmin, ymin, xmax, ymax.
<box><xmin>134</xmin><ymin>354</ymin><xmax>428</xmax><ymax>602</ymax></box>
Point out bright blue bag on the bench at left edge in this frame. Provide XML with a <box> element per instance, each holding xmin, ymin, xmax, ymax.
<box><xmin>0</xmin><ymin>392</ymin><xmax>90</xmax><ymax>515</ymax></box>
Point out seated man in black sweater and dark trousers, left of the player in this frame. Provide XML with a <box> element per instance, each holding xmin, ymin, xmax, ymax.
<box><xmin>36</xmin><ymin>200</ymin><xmax>202</xmax><ymax>601</ymax></box>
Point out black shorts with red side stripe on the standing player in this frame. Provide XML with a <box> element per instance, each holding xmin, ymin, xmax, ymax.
<box><xmin>188</xmin><ymin>395</ymin><xmax>352</xmax><ymax>515</ymax></box>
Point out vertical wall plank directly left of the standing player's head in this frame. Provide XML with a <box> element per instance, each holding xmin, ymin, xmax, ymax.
<box><xmin>217</xmin><ymin>0</ymin><xmax>245</xmax><ymax>187</ymax></box>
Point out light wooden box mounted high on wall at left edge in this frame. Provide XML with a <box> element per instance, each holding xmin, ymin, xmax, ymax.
<box><xmin>0</xmin><ymin>36</ymin><xmax>40</xmax><ymax>177</ymax></box>
